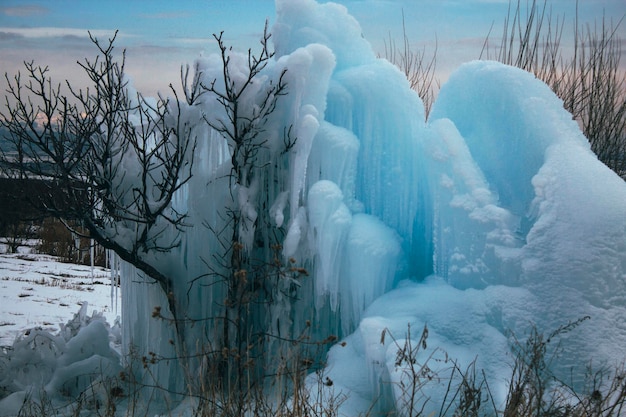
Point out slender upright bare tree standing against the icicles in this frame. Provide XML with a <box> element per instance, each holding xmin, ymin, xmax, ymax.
<box><xmin>186</xmin><ymin>23</ymin><xmax>319</xmax><ymax>406</ymax></box>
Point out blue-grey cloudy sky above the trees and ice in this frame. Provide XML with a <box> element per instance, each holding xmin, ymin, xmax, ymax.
<box><xmin>0</xmin><ymin>0</ymin><xmax>626</xmax><ymax>99</ymax></box>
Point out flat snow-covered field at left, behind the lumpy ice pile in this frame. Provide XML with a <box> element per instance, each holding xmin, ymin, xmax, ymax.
<box><xmin>0</xmin><ymin>248</ymin><xmax>121</xmax><ymax>346</ymax></box>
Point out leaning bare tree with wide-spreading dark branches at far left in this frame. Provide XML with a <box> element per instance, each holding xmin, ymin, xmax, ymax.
<box><xmin>0</xmin><ymin>30</ymin><xmax>195</xmax><ymax>342</ymax></box>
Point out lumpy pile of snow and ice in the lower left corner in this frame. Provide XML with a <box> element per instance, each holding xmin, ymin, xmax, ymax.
<box><xmin>0</xmin><ymin>302</ymin><xmax>122</xmax><ymax>416</ymax></box>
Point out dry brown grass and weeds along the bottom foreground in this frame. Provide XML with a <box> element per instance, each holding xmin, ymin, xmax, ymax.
<box><xmin>8</xmin><ymin>317</ymin><xmax>626</xmax><ymax>417</ymax></box>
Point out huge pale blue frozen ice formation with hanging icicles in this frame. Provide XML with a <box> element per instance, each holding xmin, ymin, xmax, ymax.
<box><xmin>3</xmin><ymin>0</ymin><xmax>626</xmax><ymax>415</ymax></box>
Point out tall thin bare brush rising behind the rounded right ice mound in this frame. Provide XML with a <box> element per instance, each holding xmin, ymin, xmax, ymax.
<box><xmin>481</xmin><ymin>0</ymin><xmax>626</xmax><ymax>179</ymax></box>
